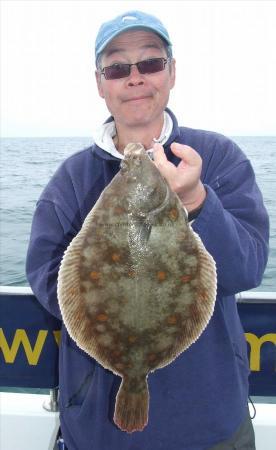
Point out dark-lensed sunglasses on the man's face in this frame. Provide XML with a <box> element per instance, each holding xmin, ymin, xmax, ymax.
<box><xmin>101</xmin><ymin>58</ymin><xmax>168</xmax><ymax>80</ymax></box>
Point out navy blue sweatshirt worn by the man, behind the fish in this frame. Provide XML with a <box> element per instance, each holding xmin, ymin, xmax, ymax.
<box><xmin>27</xmin><ymin>110</ymin><xmax>269</xmax><ymax>450</ymax></box>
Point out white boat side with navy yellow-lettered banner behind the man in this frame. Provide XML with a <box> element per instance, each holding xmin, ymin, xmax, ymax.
<box><xmin>0</xmin><ymin>286</ymin><xmax>276</xmax><ymax>450</ymax></box>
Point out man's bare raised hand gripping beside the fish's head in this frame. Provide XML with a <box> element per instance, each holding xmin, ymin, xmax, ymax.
<box><xmin>153</xmin><ymin>143</ymin><xmax>206</xmax><ymax>212</ymax></box>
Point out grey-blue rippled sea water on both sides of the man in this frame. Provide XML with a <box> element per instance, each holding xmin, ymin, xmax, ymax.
<box><xmin>0</xmin><ymin>136</ymin><xmax>276</xmax><ymax>291</ymax></box>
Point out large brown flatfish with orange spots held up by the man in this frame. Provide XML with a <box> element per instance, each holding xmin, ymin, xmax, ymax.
<box><xmin>58</xmin><ymin>144</ymin><xmax>216</xmax><ymax>433</ymax></box>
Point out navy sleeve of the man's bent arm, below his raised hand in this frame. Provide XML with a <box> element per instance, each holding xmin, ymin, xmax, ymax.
<box><xmin>193</xmin><ymin>159</ymin><xmax>269</xmax><ymax>295</ymax></box>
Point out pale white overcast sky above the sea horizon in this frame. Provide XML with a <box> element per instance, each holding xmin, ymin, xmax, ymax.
<box><xmin>0</xmin><ymin>0</ymin><xmax>276</xmax><ymax>137</ymax></box>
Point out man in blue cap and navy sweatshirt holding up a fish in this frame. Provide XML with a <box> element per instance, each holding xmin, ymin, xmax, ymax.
<box><xmin>27</xmin><ymin>11</ymin><xmax>268</xmax><ymax>450</ymax></box>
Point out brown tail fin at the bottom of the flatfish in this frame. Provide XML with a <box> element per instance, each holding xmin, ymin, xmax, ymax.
<box><xmin>114</xmin><ymin>379</ymin><xmax>149</xmax><ymax>433</ymax></box>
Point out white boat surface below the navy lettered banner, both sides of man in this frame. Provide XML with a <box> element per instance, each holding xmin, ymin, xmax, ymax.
<box><xmin>0</xmin><ymin>392</ymin><xmax>276</xmax><ymax>450</ymax></box>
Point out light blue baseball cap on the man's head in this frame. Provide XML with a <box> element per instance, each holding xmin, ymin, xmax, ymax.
<box><xmin>95</xmin><ymin>11</ymin><xmax>172</xmax><ymax>62</ymax></box>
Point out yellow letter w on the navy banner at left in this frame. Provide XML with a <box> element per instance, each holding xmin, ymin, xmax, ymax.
<box><xmin>0</xmin><ymin>328</ymin><xmax>48</xmax><ymax>366</ymax></box>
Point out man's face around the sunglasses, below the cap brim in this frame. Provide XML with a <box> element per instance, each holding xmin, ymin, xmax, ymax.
<box><xmin>96</xmin><ymin>30</ymin><xmax>175</xmax><ymax>127</ymax></box>
